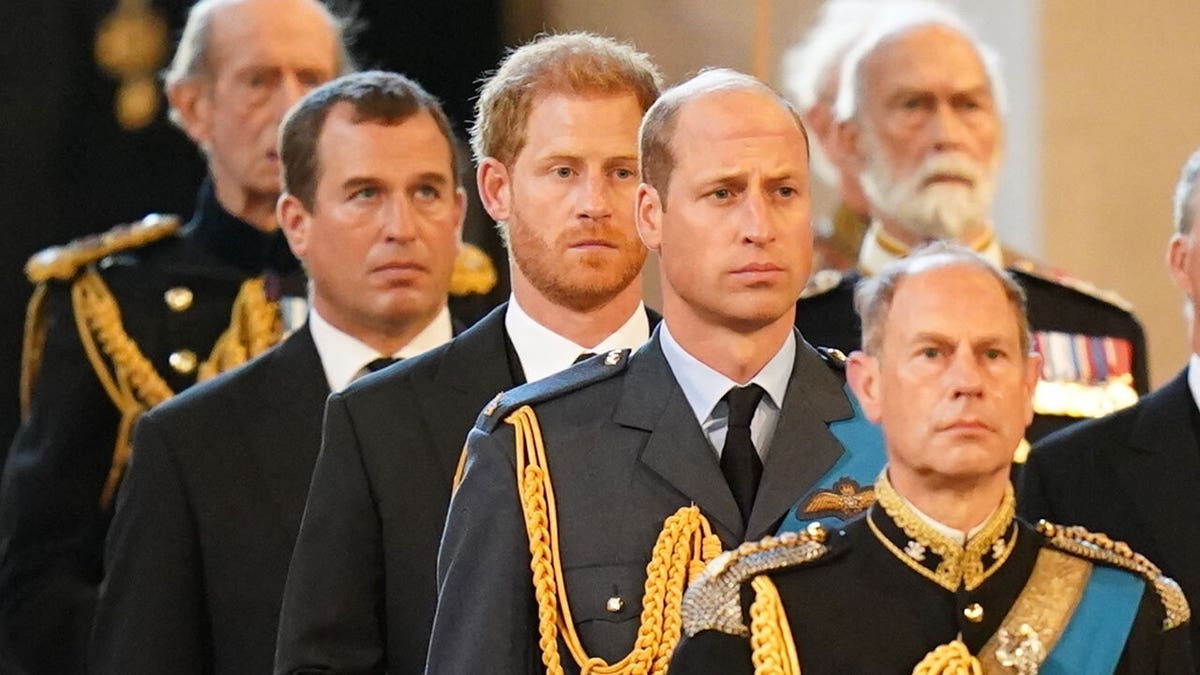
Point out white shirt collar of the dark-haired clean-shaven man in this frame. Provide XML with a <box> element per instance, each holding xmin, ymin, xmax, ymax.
<box><xmin>308</xmin><ymin>306</ymin><xmax>454</xmax><ymax>393</ymax></box>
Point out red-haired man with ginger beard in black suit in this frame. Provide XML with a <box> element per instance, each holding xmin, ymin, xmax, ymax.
<box><xmin>276</xmin><ymin>34</ymin><xmax>660</xmax><ymax>674</ymax></box>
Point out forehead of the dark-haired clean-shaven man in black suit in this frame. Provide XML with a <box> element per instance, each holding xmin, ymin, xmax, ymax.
<box><xmin>318</xmin><ymin>101</ymin><xmax>454</xmax><ymax>183</ymax></box>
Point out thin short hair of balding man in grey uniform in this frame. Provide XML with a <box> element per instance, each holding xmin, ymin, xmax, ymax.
<box><xmin>637</xmin><ymin>68</ymin><xmax>810</xmax><ymax>210</ymax></box>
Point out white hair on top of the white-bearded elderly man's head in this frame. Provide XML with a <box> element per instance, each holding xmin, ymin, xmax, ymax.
<box><xmin>835</xmin><ymin>2</ymin><xmax>1008</xmax><ymax>121</ymax></box>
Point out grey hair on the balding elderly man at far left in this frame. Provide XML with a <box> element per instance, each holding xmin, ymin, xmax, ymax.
<box><xmin>161</xmin><ymin>0</ymin><xmax>361</xmax><ymax>127</ymax></box>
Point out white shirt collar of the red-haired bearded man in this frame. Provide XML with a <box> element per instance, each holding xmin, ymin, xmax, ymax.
<box><xmin>504</xmin><ymin>295</ymin><xmax>650</xmax><ymax>382</ymax></box>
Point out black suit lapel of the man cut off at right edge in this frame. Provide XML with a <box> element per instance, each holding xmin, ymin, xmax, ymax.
<box><xmin>1109</xmin><ymin>369</ymin><xmax>1200</xmax><ymax>574</ymax></box>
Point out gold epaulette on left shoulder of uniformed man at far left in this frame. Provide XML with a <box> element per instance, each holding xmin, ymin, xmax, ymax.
<box><xmin>25</xmin><ymin>214</ymin><xmax>180</xmax><ymax>283</ymax></box>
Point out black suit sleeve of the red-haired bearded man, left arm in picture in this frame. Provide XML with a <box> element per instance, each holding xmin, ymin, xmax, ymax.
<box><xmin>275</xmin><ymin>394</ymin><xmax>386</xmax><ymax>675</ymax></box>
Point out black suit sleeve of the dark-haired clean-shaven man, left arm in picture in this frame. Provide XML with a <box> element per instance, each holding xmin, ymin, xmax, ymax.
<box><xmin>89</xmin><ymin>413</ymin><xmax>211</xmax><ymax>675</ymax></box>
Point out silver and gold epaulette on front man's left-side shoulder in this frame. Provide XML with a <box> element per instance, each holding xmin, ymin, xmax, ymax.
<box><xmin>682</xmin><ymin>522</ymin><xmax>829</xmax><ymax>637</ymax></box>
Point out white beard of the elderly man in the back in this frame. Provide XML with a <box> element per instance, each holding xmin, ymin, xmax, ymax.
<box><xmin>859</xmin><ymin>130</ymin><xmax>1000</xmax><ymax>243</ymax></box>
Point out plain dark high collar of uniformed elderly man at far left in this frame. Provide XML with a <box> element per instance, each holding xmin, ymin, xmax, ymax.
<box><xmin>187</xmin><ymin>179</ymin><xmax>300</xmax><ymax>275</ymax></box>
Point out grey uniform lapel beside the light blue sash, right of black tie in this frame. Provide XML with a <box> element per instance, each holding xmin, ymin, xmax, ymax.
<box><xmin>746</xmin><ymin>335</ymin><xmax>853</xmax><ymax>540</ymax></box>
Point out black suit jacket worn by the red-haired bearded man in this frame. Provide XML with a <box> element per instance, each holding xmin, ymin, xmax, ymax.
<box><xmin>276</xmin><ymin>304</ymin><xmax>660</xmax><ymax>674</ymax></box>
